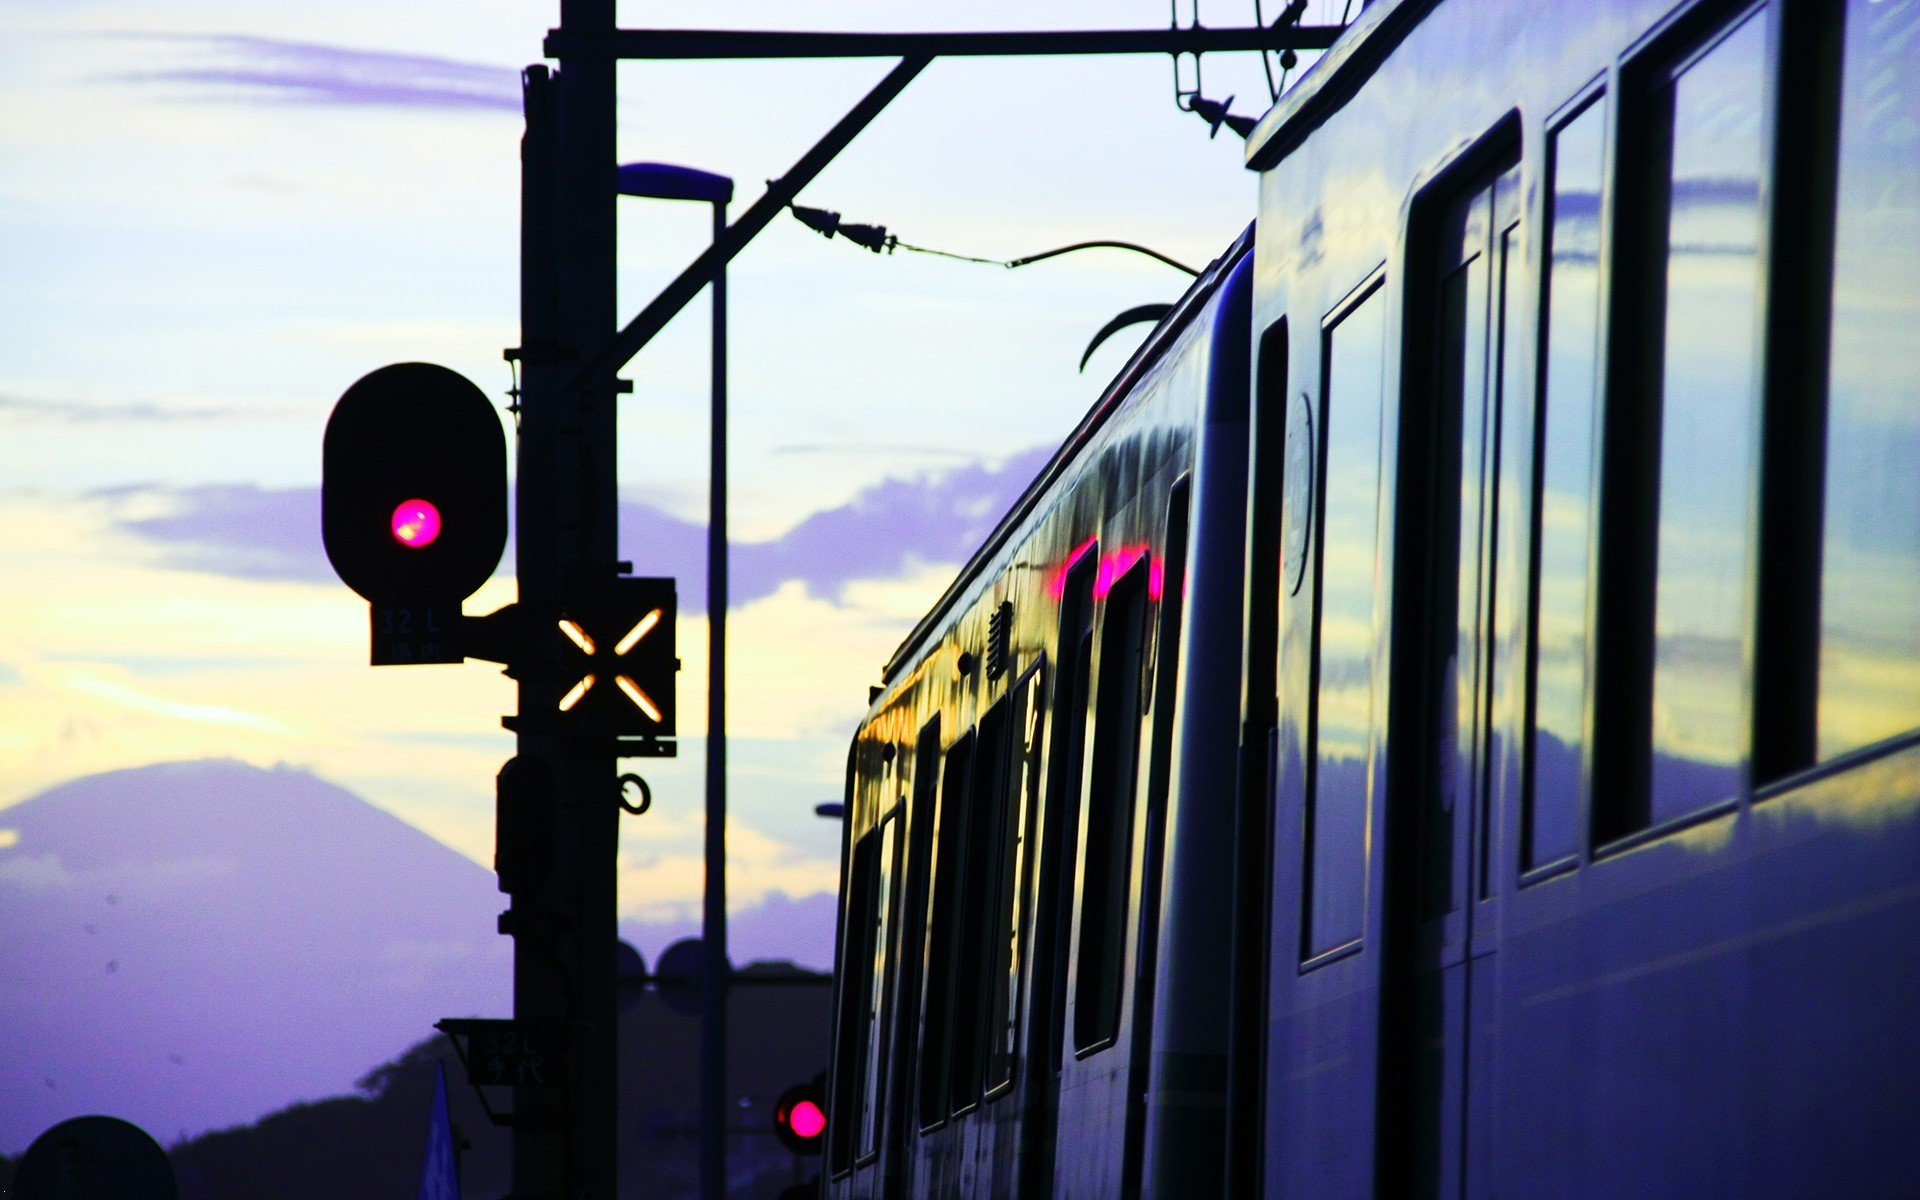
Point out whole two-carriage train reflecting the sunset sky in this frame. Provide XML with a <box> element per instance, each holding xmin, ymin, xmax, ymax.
<box><xmin>826</xmin><ymin>0</ymin><xmax>1920</xmax><ymax>1198</ymax></box>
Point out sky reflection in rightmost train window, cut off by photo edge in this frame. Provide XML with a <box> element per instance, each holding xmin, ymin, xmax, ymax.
<box><xmin>1818</xmin><ymin>0</ymin><xmax>1920</xmax><ymax>758</ymax></box>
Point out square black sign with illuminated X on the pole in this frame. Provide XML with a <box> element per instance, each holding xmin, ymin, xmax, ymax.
<box><xmin>559</xmin><ymin>578</ymin><xmax>680</xmax><ymax>737</ymax></box>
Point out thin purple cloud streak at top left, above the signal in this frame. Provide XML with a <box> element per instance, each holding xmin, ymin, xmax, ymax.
<box><xmin>111</xmin><ymin>35</ymin><xmax>520</xmax><ymax>113</ymax></box>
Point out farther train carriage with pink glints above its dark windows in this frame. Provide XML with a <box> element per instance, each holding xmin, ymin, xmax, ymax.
<box><xmin>824</xmin><ymin>236</ymin><xmax>1250</xmax><ymax>1200</ymax></box>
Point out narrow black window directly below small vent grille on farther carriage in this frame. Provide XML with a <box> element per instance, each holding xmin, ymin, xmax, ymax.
<box><xmin>948</xmin><ymin>697</ymin><xmax>1008</xmax><ymax>1112</ymax></box>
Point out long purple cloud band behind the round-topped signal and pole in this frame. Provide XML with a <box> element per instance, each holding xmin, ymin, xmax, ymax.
<box><xmin>94</xmin><ymin>447</ymin><xmax>1052</xmax><ymax>612</ymax></box>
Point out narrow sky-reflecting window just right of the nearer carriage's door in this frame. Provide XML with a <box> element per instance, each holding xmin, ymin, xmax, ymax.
<box><xmin>1523</xmin><ymin>96</ymin><xmax>1607</xmax><ymax>868</ymax></box>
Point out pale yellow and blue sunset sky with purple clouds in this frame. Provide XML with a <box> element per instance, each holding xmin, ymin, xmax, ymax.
<box><xmin>0</xmin><ymin>0</ymin><xmax>1338</xmax><ymax>944</ymax></box>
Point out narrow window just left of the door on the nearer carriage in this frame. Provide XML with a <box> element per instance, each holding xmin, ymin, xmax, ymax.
<box><xmin>1302</xmin><ymin>276</ymin><xmax>1386</xmax><ymax>958</ymax></box>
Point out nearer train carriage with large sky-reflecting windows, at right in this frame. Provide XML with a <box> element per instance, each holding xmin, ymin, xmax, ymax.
<box><xmin>1231</xmin><ymin>0</ymin><xmax>1920</xmax><ymax>1198</ymax></box>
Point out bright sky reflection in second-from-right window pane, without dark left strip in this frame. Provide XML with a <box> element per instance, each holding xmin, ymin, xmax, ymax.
<box><xmin>1647</xmin><ymin>12</ymin><xmax>1766</xmax><ymax>824</ymax></box>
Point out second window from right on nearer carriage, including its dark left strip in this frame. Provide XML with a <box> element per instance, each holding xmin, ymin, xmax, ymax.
<box><xmin>1594</xmin><ymin>6</ymin><xmax>1768</xmax><ymax>839</ymax></box>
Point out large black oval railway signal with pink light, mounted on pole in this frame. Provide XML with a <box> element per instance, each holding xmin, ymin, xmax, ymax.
<box><xmin>321</xmin><ymin>363</ymin><xmax>507</xmax><ymax>666</ymax></box>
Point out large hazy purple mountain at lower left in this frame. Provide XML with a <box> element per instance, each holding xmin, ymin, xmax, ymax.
<box><xmin>0</xmin><ymin>760</ymin><xmax>513</xmax><ymax>1154</ymax></box>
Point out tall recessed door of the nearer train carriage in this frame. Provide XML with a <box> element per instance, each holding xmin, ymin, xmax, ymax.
<box><xmin>1377</xmin><ymin>156</ymin><xmax>1521</xmax><ymax>1200</ymax></box>
